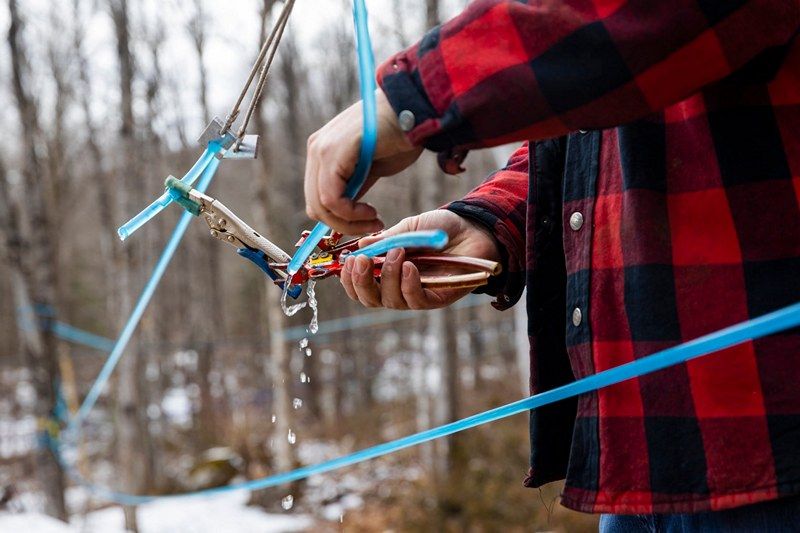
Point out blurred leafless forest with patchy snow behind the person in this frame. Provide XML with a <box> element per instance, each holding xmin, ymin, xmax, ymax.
<box><xmin>0</xmin><ymin>0</ymin><xmax>596</xmax><ymax>531</ymax></box>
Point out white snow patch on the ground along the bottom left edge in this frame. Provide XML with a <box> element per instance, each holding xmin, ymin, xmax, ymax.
<box><xmin>0</xmin><ymin>491</ymin><xmax>313</xmax><ymax>533</ymax></box>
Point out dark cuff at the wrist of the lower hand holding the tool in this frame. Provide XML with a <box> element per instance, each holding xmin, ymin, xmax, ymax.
<box><xmin>445</xmin><ymin>200</ymin><xmax>525</xmax><ymax>311</ymax></box>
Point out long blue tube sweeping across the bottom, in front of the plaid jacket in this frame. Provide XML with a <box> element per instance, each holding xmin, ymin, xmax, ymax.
<box><xmin>61</xmin><ymin>303</ymin><xmax>800</xmax><ymax>505</ymax></box>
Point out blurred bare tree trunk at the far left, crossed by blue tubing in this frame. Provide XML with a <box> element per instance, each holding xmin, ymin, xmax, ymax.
<box><xmin>0</xmin><ymin>0</ymin><xmax>67</xmax><ymax>520</ymax></box>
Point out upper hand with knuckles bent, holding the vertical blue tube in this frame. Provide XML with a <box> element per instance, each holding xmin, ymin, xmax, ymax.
<box><xmin>305</xmin><ymin>89</ymin><xmax>422</xmax><ymax>235</ymax></box>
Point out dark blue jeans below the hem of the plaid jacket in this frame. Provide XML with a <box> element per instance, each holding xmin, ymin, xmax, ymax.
<box><xmin>600</xmin><ymin>497</ymin><xmax>800</xmax><ymax>533</ymax></box>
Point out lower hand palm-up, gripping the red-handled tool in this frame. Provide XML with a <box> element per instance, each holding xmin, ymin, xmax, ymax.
<box><xmin>341</xmin><ymin>209</ymin><xmax>500</xmax><ymax>309</ymax></box>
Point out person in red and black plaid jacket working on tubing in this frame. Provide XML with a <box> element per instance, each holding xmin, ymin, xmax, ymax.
<box><xmin>305</xmin><ymin>0</ymin><xmax>800</xmax><ymax>531</ymax></box>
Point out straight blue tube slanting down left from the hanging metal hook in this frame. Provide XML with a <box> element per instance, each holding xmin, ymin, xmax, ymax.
<box><xmin>67</xmin><ymin>155</ymin><xmax>219</xmax><ymax>436</ymax></box>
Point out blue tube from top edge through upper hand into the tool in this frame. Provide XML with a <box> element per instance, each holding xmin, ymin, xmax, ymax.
<box><xmin>287</xmin><ymin>0</ymin><xmax>378</xmax><ymax>275</ymax></box>
